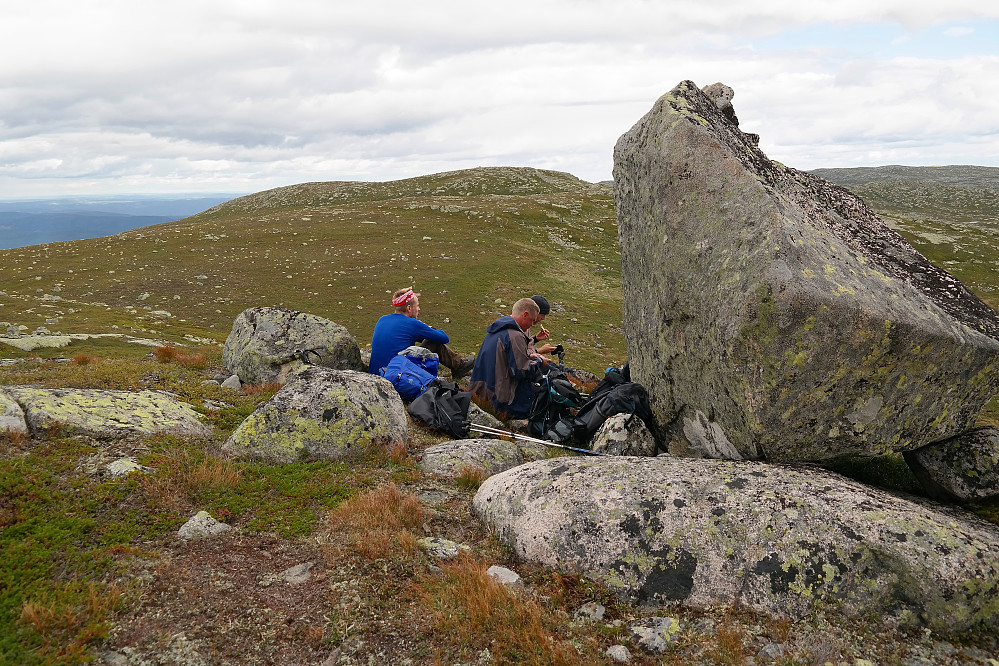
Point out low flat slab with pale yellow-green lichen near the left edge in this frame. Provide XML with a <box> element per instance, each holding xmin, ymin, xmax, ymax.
<box><xmin>4</xmin><ymin>386</ymin><xmax>211</xmax><ymax>439</ymax></box>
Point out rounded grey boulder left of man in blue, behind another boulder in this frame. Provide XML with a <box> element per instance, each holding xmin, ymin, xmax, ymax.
<box><xmin>222</xmin><ymin>307</ymin><xmax>366</xmax><ymax>384</ymax></box>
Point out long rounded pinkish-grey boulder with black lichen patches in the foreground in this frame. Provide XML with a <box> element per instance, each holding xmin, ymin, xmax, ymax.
<box><xmin>473</xmin><ymin>456</ymin><xmax>999</xmax><ymax>631</ymax></box>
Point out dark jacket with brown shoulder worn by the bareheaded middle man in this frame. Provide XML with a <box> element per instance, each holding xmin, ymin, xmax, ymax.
<box><xmin>469</xmin><ymin>315</ymin><xmax>541</xmax><ymax>419</ymax></box>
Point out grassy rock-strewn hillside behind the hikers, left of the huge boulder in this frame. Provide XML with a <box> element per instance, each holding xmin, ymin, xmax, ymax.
<box><xmin>0</xmin><ymin>168</ymin><xmax>625</xmax><ymax>371</ymax></box>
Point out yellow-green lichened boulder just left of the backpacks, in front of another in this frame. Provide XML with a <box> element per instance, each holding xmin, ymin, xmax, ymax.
<box><xmin>222</xmin><ymin>367</ymin><xmax>407</xmax><ymax>462</ymax></box>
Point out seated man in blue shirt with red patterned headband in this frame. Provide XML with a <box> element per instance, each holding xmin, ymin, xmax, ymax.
<box><xmin>368</xmin><ymin>287</ymin><xmax>475</xmax><ymax>380</ymax></box>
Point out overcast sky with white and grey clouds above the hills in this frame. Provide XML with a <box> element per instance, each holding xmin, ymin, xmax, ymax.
<box><xmin>0</xmin><ymin>0</ymin><xmax>999</xmax><ymax>198</ymax></box>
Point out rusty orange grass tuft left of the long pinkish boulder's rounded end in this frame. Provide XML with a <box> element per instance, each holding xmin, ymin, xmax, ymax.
<box><xmin>329</xmin><ymin>483</ymin><xmax>427</xmax><ymax>560</ymax></box>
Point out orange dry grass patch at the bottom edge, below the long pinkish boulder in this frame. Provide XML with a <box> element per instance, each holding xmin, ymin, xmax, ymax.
<box><xmin>418</xmin><ymin>555</ymin><xmax>592</xmax><ymax>666</ymax></box>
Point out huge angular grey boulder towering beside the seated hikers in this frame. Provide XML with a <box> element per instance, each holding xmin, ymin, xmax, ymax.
<box><xmin>614</xmin><ymin>81</ymin><xmax>999</xmax><ymax>461</ymax></box>
